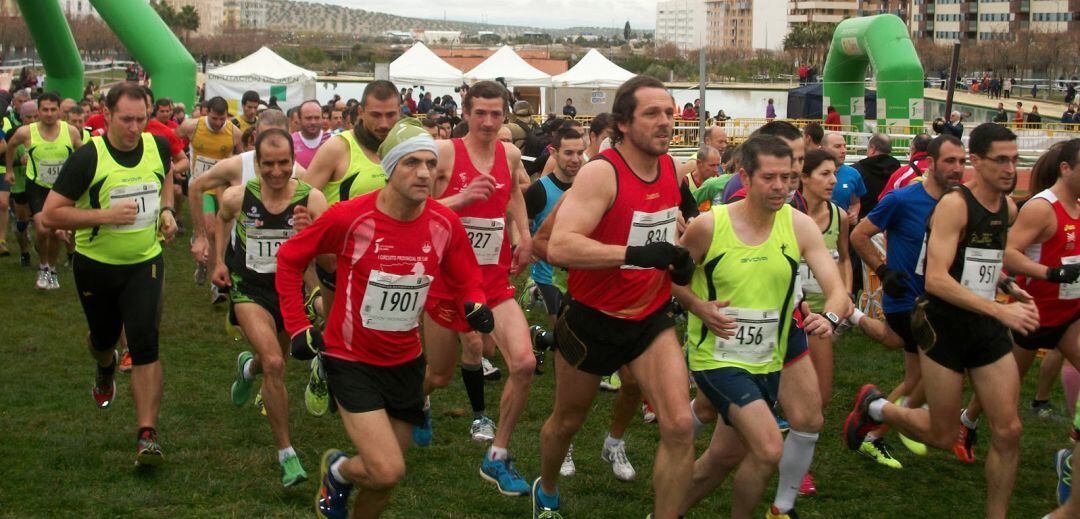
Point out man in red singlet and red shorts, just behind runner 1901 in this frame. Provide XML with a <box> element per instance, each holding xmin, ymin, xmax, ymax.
<box><xmin>414</xmin><ymin>81</ymin><xmax>536</xmax><ymax>495</ymax></box>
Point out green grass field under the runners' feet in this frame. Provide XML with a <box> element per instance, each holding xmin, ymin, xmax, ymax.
<box><xmin>0</xmin><ymin>228</ymin><xmax>1068</xmax><ymax>518</ymax></box>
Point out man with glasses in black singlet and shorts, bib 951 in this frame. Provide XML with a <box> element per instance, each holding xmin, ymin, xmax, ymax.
<box><xmin>843</xmin><ymin>123</ymin><xmax>1039</xmax><ymax>519</ymax></box>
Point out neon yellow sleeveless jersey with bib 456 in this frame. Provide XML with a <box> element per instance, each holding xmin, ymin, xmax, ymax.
<box><xmin>687</xmin><ymin>205</ymin><xmax>801</xmax><ymax>374</ymax></box>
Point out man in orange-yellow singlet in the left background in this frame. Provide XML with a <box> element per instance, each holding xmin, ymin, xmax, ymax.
<box><xmin>176</xmin><ymin>96</ymin><xmax>241</xmax><ymax>303</ymax></box>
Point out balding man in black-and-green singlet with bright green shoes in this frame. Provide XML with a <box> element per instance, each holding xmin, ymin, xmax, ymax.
<box><xmin>212</xmin><ymin>128</ymin><xmax>326</xmax><ymax>487</ymax></box>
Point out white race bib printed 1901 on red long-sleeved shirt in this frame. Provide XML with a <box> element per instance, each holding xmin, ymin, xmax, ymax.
<box><xmin>360</xmin><ymin>270</ymin><xmax>432</xmax><ymax>331</ymax></box>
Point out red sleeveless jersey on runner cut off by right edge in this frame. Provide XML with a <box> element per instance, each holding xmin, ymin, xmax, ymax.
<box><xmin>1016</xmin><ymin>189</ymin><xmax>1080</xmax><ymax>327</ymax></box>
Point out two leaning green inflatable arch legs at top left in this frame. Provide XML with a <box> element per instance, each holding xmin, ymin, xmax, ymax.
<box><xmin>18</xmin><ymin>0</ymin><xmax>195</xmax><ymax>108</ymax></box>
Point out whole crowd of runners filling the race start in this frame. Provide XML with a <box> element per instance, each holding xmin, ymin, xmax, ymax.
<box><xmin>0</xmin><ymin>68</ymin><xmax>1080</xmax><ymax>519</ymax></box>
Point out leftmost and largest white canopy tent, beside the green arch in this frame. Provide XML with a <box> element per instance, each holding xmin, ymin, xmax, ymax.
<box><xmin>206</xmin><ymin>46</ymin><xmax>316</xmax><ymax>113</ymax></box>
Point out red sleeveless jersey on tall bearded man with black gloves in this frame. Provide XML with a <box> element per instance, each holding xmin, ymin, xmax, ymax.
<box><xmin>567</xmin><ymin>143</ymin><xmax>681</xmax><ymax>320</ymax></box>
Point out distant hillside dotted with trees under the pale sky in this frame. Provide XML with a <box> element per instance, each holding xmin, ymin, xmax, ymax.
<box><xmin>267</xmin><ymin>0</ymin><xmax>622</xmax><ymax>38</ymax></box>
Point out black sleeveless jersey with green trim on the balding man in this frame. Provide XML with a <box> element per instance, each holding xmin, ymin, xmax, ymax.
<box><xmin>226</xmin><ymin>179</ymin><xmax>311</xmax><ymax>284</ymax></box>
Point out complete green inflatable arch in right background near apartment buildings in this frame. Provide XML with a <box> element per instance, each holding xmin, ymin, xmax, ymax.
<box><xmin>822</xmin><ymin>14</ymin><xmax>923</xmax><ymax>133</ymax></box>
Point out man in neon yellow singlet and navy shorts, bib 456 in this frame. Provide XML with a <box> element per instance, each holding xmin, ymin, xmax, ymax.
<box><xmin>675</xmin><ymin>135</ymin><xmax>850</xmax><ymax>518</ymax></box>
